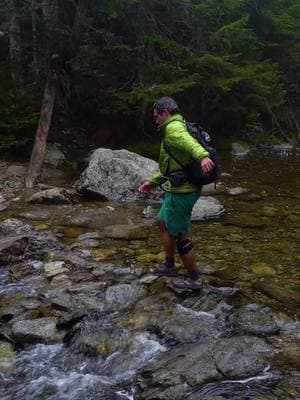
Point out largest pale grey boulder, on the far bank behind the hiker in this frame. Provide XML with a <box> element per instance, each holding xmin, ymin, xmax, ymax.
<box><xmin>78</xmin><ymin>148</ymin><xmax>160</xmax><ymax>201</ymax></box>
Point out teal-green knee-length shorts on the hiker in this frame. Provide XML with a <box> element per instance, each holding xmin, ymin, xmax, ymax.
<box><xmin>158</xmin><ymin>192</ymin><xmax>200</xmax><ymax>238</ymax></box>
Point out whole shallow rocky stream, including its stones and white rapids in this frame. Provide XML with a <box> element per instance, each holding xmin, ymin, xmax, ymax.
<box><xmin>0</xmin><ymin>151</ymin><xmax>300</xmax><ymax>400</ymax></box>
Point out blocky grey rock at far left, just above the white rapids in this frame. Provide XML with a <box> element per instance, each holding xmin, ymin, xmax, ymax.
<box><xmin>12</xmin><ymin>317</ymin><xmax>61</xmax><ymax>344</ymax></box>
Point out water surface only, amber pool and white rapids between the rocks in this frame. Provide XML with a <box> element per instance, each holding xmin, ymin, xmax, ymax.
<box><xmin>0</xmin><ymin>148</ymin><xmax>300</xmax><ymax>400</ymax></box>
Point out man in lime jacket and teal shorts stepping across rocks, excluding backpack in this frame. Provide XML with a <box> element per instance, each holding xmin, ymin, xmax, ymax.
<box><xmin>138</xmin><ymin>97</ymin><xmax>214</xmax><ymax>289</ymax></box>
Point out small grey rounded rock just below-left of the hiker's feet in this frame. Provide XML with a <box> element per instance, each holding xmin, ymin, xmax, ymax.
<box><xmin>105</xmin><ymin>284</ymin><xmax>144</xmax><ymax>310</ymax></box>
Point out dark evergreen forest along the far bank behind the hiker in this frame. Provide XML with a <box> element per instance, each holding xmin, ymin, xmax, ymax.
<box><xmin>0</xmin><ymin>0</ymin><xmax>300</xmax><ymax>157</ymax></box>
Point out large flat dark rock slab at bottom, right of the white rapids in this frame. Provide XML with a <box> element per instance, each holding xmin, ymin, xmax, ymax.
<box><xmin>137</xmin><ymin>336</ymin><xmax>272</xmax><ymax>400</ymax></box>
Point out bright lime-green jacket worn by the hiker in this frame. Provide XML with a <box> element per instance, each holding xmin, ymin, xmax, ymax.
<box><xmin>149</xmin><ymin>114</ymin><xmax>209</xmax><ymax>193</ymax></box>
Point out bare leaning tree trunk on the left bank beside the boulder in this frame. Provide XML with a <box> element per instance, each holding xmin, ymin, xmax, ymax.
<box><xmin>25</xmin><ymin>54</ymin><xmax>63</xmax><ymax>188</ymax></box>
